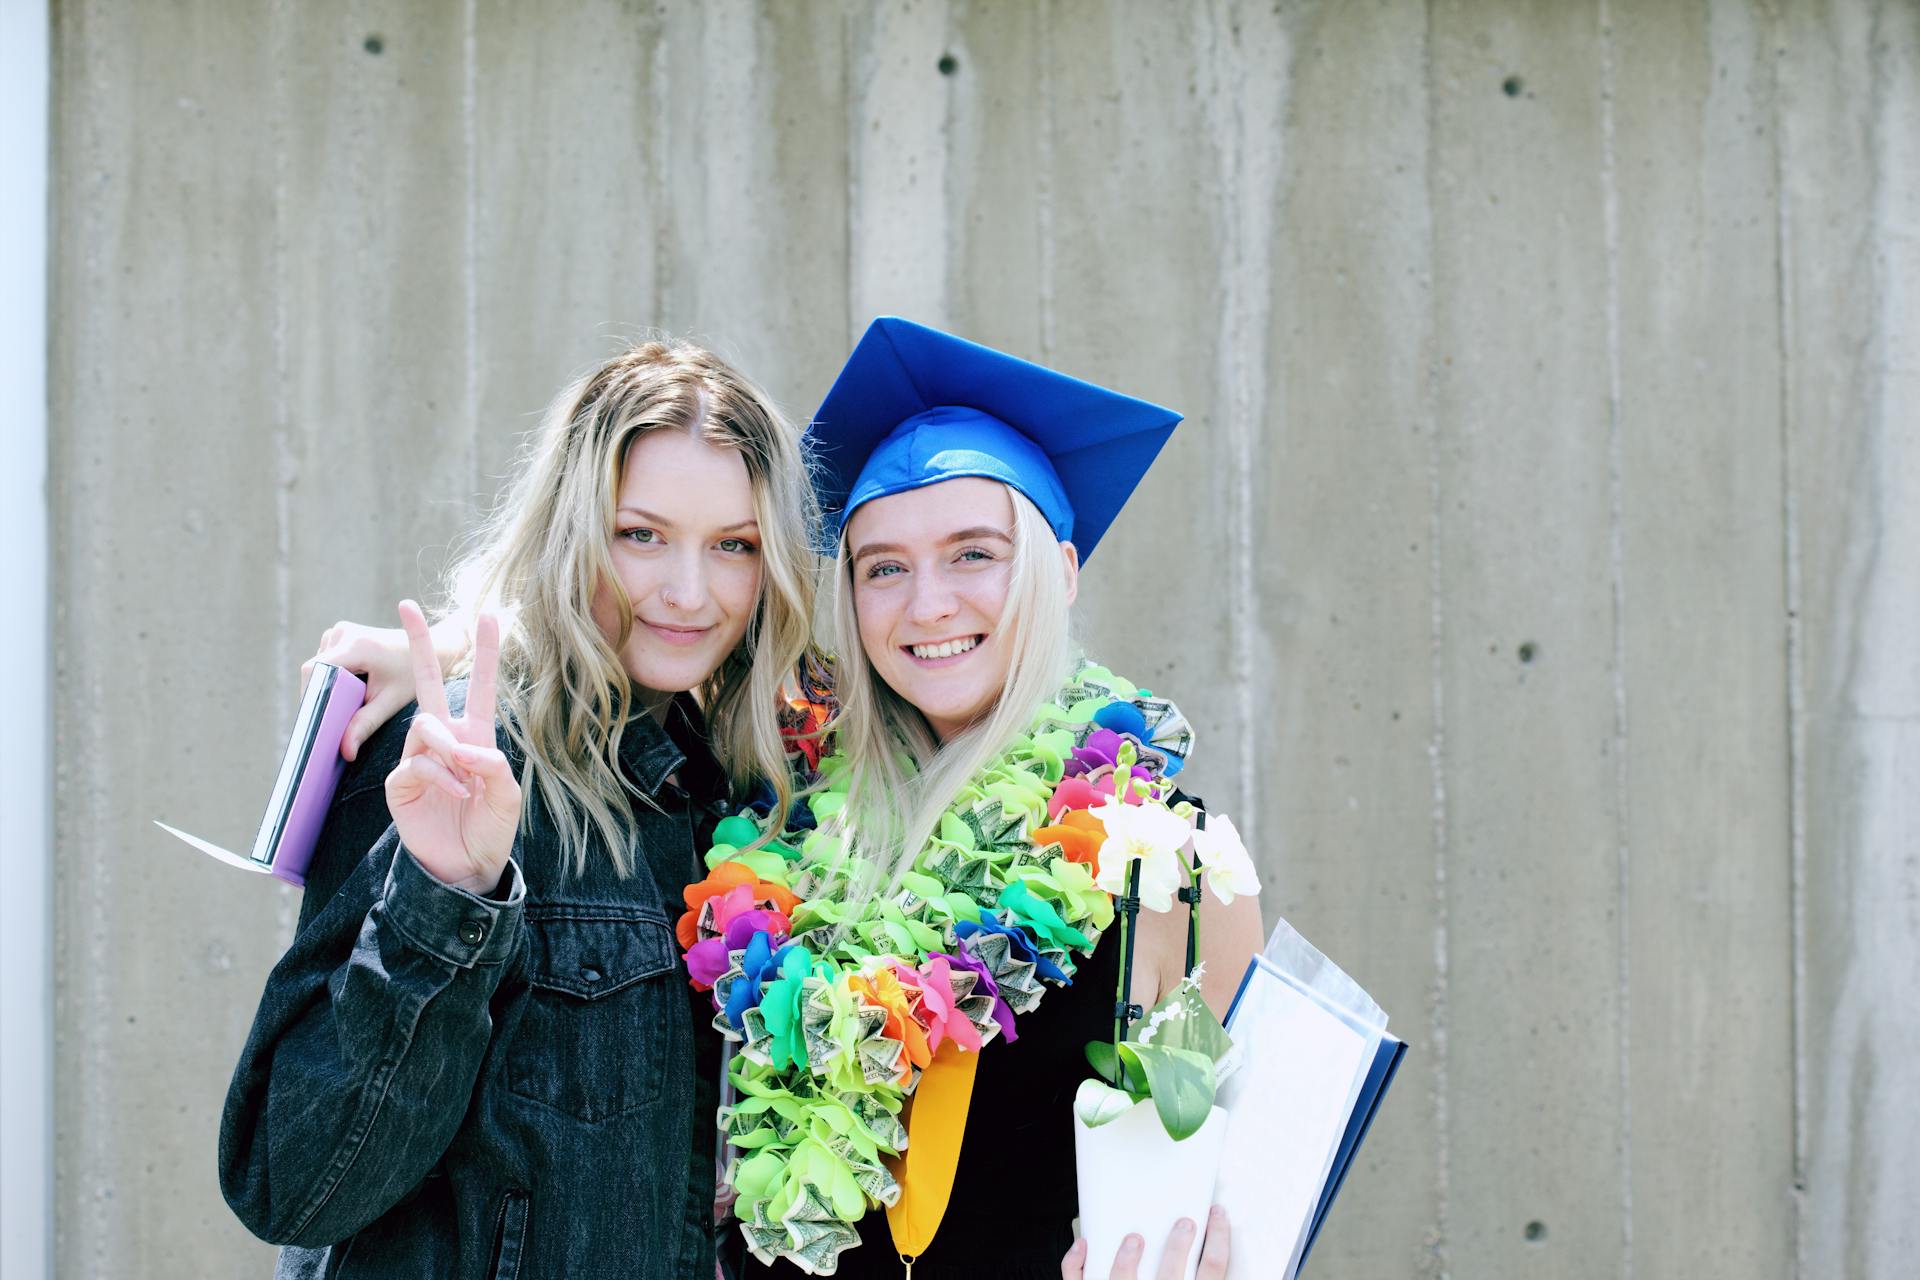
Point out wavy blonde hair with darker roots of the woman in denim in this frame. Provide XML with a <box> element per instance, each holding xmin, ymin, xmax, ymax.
<box><xmin>451</xmin><ymin>342</ymin><xmax>818</xmax><ymax>875</ymax></box>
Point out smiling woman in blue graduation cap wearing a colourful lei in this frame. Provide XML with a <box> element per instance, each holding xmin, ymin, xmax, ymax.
<box><xmin>682</xmin><ymin>319</ymin><xmax>1261</xmax><ymax>1280</ymax></box>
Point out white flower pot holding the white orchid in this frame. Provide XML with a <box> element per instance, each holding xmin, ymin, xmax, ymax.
<box><xmin>1073</xmin><ymin>1098</ymin><xmax>1227</xmax><ymax>1280</ymax></box>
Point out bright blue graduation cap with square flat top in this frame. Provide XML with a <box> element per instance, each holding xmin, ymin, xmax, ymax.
<box><xmin>808</xmin><ymin>317</ymin><xmax>1181</xmax><ymax>562</ymax></box>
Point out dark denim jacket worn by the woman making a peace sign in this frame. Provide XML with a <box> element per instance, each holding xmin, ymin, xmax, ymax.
<box><xmin>219</xmin><ymin>685</ymin><xmax>724</xmax><ymax>1280</ymax></box>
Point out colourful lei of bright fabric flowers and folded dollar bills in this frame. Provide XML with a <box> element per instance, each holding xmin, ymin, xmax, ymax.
<box><xmin>680</xmin><ymin>664</ymin><xmax>1192</xmax><ymax>1274</ymax></box>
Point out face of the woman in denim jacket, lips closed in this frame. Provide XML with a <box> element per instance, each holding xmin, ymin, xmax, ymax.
<box><xmin>593</xmin><ymin>430</ymin><xmax>760</xmax><ymax>710</ymax></box>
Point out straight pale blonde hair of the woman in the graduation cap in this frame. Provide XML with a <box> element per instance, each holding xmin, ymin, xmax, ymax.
<box><xmin>828</xmin><ymin>487</ymin><xmax>1075</xmax><ymax>919</ymax></box>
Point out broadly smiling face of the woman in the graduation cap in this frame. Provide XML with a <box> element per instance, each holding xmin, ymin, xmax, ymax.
<box><xmin>847</xmin><ymin>476</ymin><xmax>1075</xmax><ymax>743</ymax></box>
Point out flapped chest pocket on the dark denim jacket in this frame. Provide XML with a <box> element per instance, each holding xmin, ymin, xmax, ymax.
<box><xmin>507</xmin><ymin>904</ymin><xmax>685</xmax><ymax>1125</ymax></box>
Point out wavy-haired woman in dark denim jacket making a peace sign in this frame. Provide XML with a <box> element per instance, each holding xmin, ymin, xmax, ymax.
<box><xmin>219</xmin><ymin>344</ymin><xmax>812</xmax><ymax>1280</ymax></box>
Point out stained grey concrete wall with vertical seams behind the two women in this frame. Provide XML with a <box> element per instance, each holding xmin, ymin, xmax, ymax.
<box><xmin>50</xmin><ymin>0</ymin><xmax>1920</xmax><ymax>1280</ymax></box>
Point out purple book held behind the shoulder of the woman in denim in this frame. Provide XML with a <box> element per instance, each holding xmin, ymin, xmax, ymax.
<box><xmin>156</xmin><ymin>662</ymin><xmax>367</xmax><ymax>885</ymax></box>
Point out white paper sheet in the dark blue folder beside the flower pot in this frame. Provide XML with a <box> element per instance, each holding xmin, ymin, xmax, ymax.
<box><xmin>1213</xmin><ymin>956</ymin><xmax>1380</xmax><ymax>1280</ymax></box>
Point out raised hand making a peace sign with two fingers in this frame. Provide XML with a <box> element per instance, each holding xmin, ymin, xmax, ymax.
<box><xmin>386</xmin><ymin>601</ymin><xmax>520</xmax><ymax>894</ymax></box>
